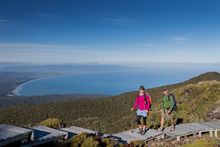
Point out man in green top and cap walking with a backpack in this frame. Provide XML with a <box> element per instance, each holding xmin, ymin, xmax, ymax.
<box><xmin>158</xmin><ymin>88</ymin><xmax>177</xmax><ymax>131</ymax></box>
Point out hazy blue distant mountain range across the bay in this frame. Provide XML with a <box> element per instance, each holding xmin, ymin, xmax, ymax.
<box><xmin>0</xmin><ymin>64</ymin><xmax>129</xmax><ymax>76</ymax></box>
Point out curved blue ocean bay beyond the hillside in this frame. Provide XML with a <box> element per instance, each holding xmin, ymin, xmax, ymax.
<box><xmin>13</xmin><ymin>69</ymin><xmax>205</xmax><ymax>96</ymax></box>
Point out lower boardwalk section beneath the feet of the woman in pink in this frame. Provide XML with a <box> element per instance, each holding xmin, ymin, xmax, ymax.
<box><xmin>112</xmin><ymin>128</ymin><xmax>163</xmax><ymax>143</ymax></box>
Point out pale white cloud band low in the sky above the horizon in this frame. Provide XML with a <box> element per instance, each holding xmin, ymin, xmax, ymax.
<box><xmin>0</xmin><ymin>43</ymin><xmax>220</xmax><ymax>63</ymax></box>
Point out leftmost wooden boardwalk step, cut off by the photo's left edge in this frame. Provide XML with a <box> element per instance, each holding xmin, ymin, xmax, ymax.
<box><xmin>0</xmin><ymin>124</ymin><xmax>32</xmax><ymax>146</ymax></box>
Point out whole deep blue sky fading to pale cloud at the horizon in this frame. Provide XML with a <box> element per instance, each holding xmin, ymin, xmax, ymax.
<box><xmin>0</xmin><ymin>0</ymin><xmax>220</xmax><ymax>64</ymax></box>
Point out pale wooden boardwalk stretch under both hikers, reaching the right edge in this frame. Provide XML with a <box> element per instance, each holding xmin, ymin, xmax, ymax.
<box><xmin>112</xmin><ymin>121</ymin><xmax>220</xmax><ymax>143</ymax></box>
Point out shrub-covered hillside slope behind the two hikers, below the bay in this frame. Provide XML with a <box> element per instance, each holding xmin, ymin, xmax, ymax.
<box><xmin>0</xmin><ymin>72</ymin><xmax>220</xmax><ymax>133</ymax></box>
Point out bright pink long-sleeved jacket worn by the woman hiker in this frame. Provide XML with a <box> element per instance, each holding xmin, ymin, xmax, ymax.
<box><xmin>133</xmin><ymin>95</ymin><xmax>150</xmax><ymax>111</ymax></box>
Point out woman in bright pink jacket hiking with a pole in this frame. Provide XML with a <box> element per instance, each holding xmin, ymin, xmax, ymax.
<box><xmin>131</xmin><ymin>86</ymin><xmax>150</xmax><ymax>135</ymax></box>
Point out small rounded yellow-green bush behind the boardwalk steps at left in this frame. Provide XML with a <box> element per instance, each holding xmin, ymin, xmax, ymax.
<box><xmin>40</xmin><ymin>118</ymin><xmax>61</xmax><ymax>128</ymax></box>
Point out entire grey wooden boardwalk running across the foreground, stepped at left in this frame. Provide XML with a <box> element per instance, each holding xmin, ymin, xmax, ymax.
<box><xmin>0</xmin><ymin>120</ymin><xmax>220</xmax><ymax>147</ymax></box>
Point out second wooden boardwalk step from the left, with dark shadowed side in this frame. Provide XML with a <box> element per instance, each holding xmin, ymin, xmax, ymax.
<box><xmin>22</xmin><ymin>126</ymin><xmax>67</xmax><ymax>147</ymax></box>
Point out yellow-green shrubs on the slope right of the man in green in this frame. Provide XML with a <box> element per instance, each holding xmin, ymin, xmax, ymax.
<box><xmin>173</xmin><ymin>81</ymin><xmax>220</xmax><ymax>122</ymax></box>
